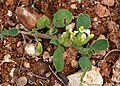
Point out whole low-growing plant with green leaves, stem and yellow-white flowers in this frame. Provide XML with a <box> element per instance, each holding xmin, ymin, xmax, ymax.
<box><xmin>0</xmin><ymin>9</ymin><xmax>108</xmax><ymax>83</ymax></box>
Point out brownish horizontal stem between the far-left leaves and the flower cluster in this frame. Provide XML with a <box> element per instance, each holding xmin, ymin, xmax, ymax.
<box><xmin>19</xmin><ymin>31</ymin><xmax>56</xmax><ymax>39</ymax></box>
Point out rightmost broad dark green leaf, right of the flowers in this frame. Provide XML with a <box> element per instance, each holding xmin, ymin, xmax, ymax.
<box><xmin>92</xmin><ymin>39</ymin><xmax>109</xmax><ymax>50</ymax></box>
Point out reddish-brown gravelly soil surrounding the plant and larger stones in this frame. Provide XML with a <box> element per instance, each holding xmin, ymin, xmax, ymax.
<box><xmin>0</xmin><ymin>0</ymin><xmax>120</xmax><ymax>86</ymax></box>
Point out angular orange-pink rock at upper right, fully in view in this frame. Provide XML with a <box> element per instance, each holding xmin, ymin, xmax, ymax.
<box><xmin>96</xmin><ymin>4</ymin><xmax>110</xmax><ymax>17</ymax></box>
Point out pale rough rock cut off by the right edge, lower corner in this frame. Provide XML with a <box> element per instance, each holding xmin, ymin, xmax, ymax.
<box><xmin>112</xmin><ymin>57</ymin><xmax>120</xmax><ymax>83</ymax></box>
